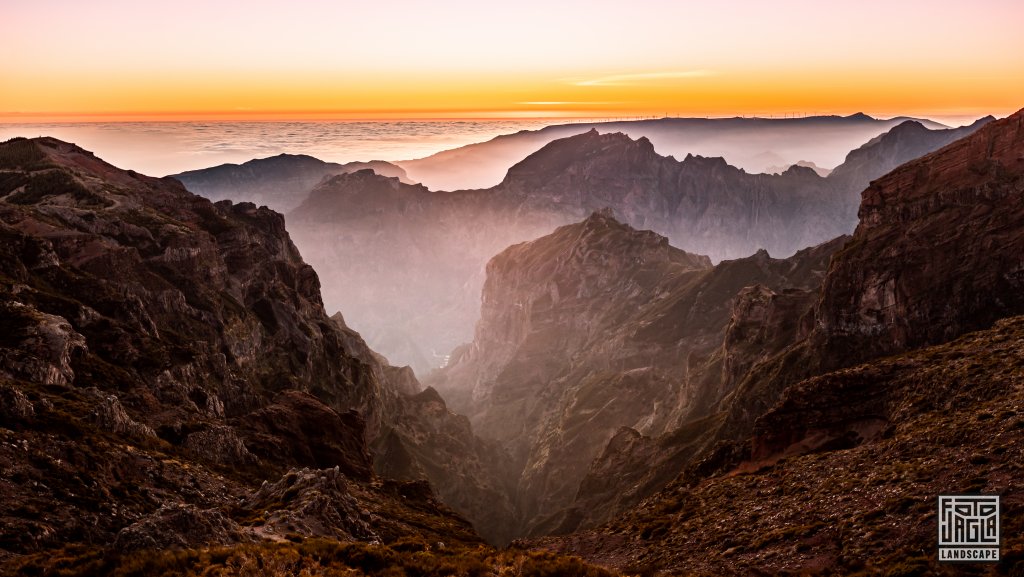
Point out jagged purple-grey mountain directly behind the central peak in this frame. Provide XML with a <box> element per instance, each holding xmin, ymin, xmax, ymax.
<box><xmin>501</xmin><ymin>130</ymin><xmax>855</xmax><ymax>260</ymax></box>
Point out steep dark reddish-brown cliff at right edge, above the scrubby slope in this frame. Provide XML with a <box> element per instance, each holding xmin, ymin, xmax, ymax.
<box><xmin>818</xmin><ymin>113</ymin><xmax>1024</xmax><ymax>359</ymax></box>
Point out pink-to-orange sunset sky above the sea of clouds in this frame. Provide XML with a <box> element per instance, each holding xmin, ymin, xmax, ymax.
<box><xmin>0</xmin><ymin>0</ymin><xmax>1024</xmax><ymax>122</ymax></box>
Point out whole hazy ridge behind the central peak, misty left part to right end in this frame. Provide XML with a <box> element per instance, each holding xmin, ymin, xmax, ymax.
<box><xmin>274</xmin><ymin>119</ymin><xmax>991</xmax><ymax>375</ymax></box>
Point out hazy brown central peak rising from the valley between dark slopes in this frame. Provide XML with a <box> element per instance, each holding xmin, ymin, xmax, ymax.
<box><xmin>427</xmin><ymin>211</ymin><xmax>840</xmax><ymax>535</ymax></box>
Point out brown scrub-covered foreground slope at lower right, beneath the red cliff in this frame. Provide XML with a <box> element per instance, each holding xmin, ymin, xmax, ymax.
<box><xmin>530</xmin><ymin>317</ymin><xmax>1024</xmax><ymax>575</ymax></box>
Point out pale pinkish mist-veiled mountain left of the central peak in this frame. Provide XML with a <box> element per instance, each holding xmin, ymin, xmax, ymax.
<box><xmin>288</xmin><ymin>170</ymin><xmax>564</xmax><ymax>375</ymax></box>
